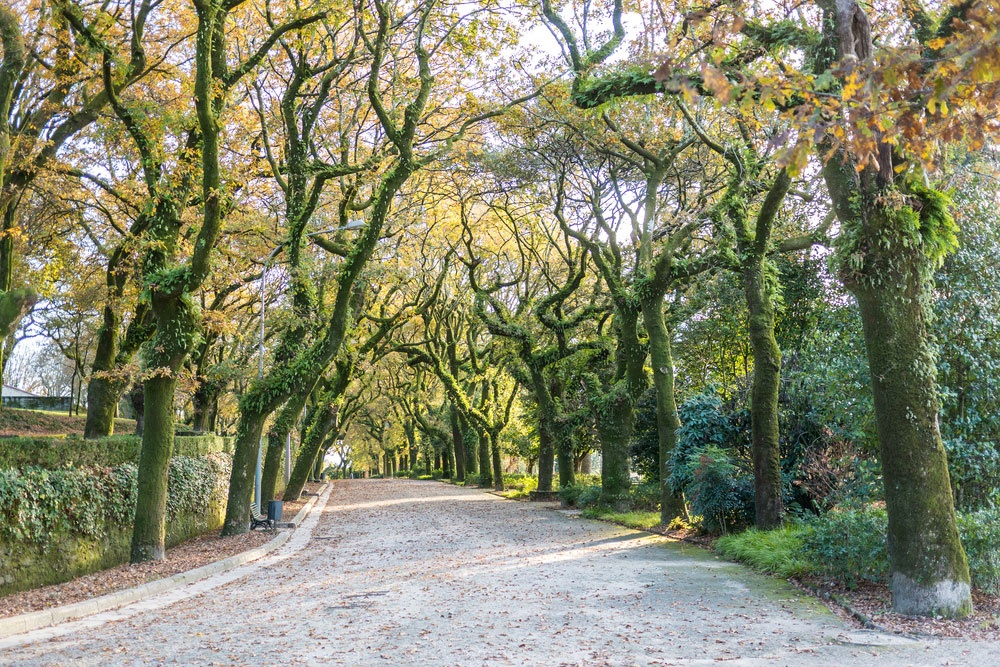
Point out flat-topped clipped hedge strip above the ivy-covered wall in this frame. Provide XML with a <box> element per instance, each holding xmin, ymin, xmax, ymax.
<box><xmin>0</xmin><ymin>433</ymin><xmax>233</xmax><ymax>470</ymax></box>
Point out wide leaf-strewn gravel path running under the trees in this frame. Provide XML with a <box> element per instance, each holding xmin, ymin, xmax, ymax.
<box><xmin>0</xmin><ymin>480</ymin><xmax>1000</xmax><ymax>667</ymax></box>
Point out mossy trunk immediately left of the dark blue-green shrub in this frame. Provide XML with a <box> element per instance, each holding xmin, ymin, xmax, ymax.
<box><xmin>642</xmin><ymin>291</ymin><xmax>687</xmax><ymax>525</ymax></box>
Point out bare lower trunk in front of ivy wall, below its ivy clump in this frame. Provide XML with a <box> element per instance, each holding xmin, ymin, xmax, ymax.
<box><xmin>131</xmin><ymin>375</ymin><xmax>177</xmax><ymax>563</ymax></box>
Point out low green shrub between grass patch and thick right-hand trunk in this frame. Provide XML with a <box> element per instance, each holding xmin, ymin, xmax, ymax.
<box><xmin>803</xmin><ymin>505</ymin><xmax>889</xmax><ymax>588</ymax></box>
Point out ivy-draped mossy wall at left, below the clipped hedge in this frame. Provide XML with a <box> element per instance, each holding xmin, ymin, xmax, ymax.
<box><xmin>0</xmin><ymin>453</ymin><xmax>232</xmax><ymax>595</ymax></box>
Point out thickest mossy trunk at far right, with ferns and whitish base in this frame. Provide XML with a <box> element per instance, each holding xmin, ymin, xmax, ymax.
<box><xmin>816</xmin><ymin>0</ymin><xmax>972</xmax><ymax>617</ymax></box>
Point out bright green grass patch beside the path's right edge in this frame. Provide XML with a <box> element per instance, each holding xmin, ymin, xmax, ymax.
<box><xmin>715</xmin><ymin>525</ymin><xmax>815</xmax><ymax>579</ymax></box>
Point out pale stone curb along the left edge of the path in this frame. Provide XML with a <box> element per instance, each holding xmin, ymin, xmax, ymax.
<box><xmin>0</xmin><ymin>494</ymin><xmax>328</xmax><ymax>639</ymax></box>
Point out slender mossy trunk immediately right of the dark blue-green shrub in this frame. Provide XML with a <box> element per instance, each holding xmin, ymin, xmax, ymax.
<box><xmin>743</xmin><ymin>257</ymin><xmax>784</xmax><ymax>530</ymax></box>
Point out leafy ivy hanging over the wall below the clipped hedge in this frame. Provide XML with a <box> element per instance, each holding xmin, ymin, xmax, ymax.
<box><xmin>0</xmin><ymin>454</ymin><xmax>231</xmax><ymax>544</ymax></box>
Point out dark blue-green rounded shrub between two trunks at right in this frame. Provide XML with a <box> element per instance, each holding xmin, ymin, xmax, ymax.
<box><xmin>682</xmin><ymin>445</ymin><xmax>753</xmax><ymax>533</ymax></box>
